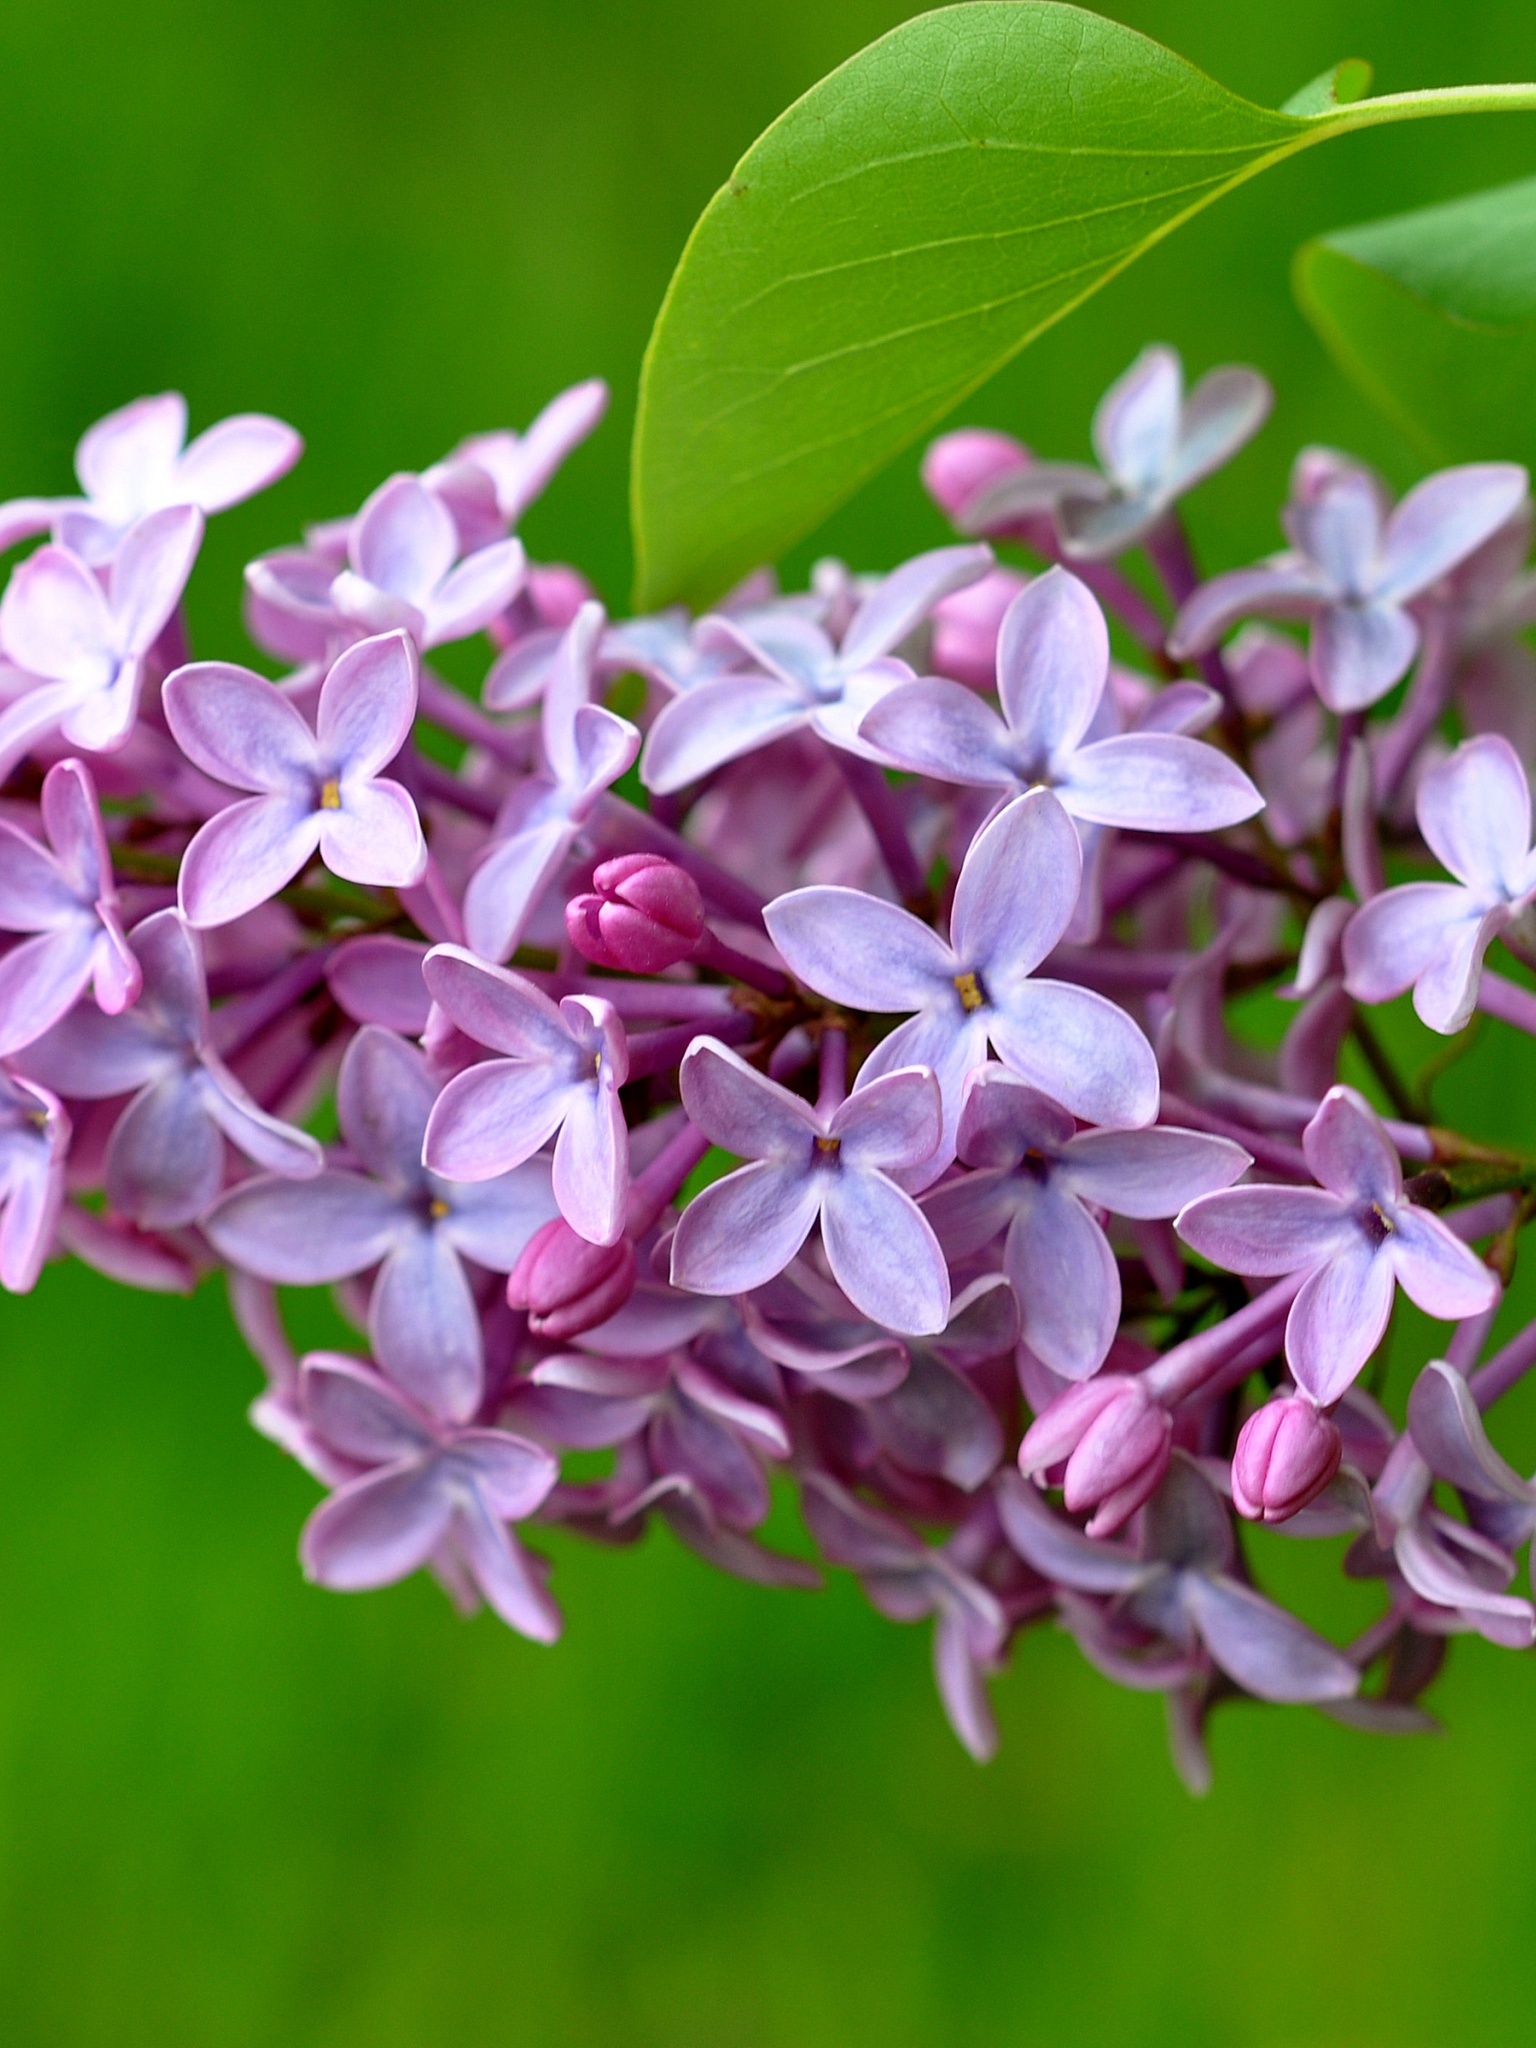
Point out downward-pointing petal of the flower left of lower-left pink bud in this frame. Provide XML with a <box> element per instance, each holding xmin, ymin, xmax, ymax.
<box><xmin>369</xmin><ymin>1227</ymin><xmax>483</xmax><ymax>1421</ymax></box>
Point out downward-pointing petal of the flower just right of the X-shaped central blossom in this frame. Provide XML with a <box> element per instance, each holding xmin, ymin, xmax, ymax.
<box><xmin>1004</xmin><ymin>1178</ymin><xmax>1120</xmax><ymax>1380</ymax></box>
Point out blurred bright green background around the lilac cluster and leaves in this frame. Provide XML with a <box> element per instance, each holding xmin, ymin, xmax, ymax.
<box><xmin>0</xmin><ymin>0</ymin><xmax>1536</xmax><ymax>2048</ymax></box>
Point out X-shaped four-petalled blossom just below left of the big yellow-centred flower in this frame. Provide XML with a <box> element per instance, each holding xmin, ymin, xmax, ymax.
<box><xmin>672</xmin><ymin>1038</ymin><xmax>950</xmax><ymax>1333</ymax></box>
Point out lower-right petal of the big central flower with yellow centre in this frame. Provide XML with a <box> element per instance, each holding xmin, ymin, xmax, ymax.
<box><xmin>987</xmin><ymin>978</ymin><xmax>1159</xmax><ymax>1128</ymax></box>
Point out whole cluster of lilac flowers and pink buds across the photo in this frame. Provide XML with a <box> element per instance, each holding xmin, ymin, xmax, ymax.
<box><xmin>0</xmin><ymin>348</ymin><xmax>1536</xmax><ymax>1786</ymax></box>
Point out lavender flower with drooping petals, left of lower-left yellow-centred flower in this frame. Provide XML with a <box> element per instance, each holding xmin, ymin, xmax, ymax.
<box><xmin>23</xmin><ymin>909</ymin><xmax>324</xmax><ymax>1231</ymax></box>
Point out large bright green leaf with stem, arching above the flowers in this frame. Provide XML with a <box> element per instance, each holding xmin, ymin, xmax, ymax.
<box><xmin>633</xmin><ymin>0</ymin><xmax>1536</xmax><ymax>606</ymax></box>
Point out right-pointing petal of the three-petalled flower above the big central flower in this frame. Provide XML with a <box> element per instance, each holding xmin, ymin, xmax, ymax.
<box><xmin>1057</xmin><ymin>733</ymin><xmax>1264</xmax><ymax>831</ymax></box>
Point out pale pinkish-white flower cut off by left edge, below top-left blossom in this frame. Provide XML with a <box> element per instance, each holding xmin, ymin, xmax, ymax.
<box><xmin>0</xmin><ymin>506</ymin><xmax>203</xmax><ymax>776</ymax></box>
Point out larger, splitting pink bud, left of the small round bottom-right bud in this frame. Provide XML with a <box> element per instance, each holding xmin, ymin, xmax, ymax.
<box><xmin>1018</xmin><ymin>1372</ymin><xmax>1174</xmax><ymax>1536</ymax></box>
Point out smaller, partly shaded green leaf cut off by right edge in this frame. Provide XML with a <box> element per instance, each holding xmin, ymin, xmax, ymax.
<box><xmin>1294</xmin><ymin>178</ymin><xmax>1536</xmax><ymax>465</ymax></box>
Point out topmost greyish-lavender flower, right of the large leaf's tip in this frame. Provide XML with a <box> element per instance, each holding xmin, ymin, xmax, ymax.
<box><xmin>963</xmin><ymin>344</ymin><xmax>1274</xmax><ymax>561</ymax></box>
